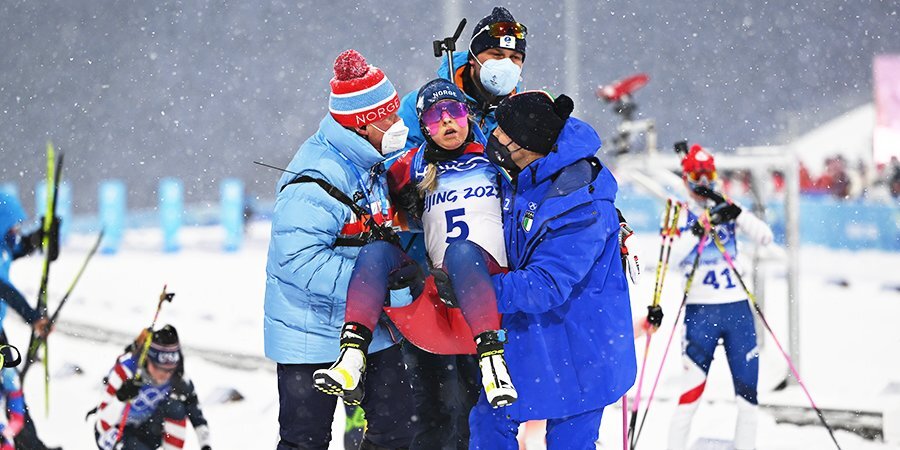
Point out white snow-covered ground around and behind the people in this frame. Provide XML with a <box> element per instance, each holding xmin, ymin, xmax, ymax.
<box><xmin>6</xmin><ymin>223</ymin><xmax>900</xmax><ymax>450</ymax></box>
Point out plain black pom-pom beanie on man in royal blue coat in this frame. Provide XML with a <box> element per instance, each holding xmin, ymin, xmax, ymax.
<box><xmin>495</xmin><ymin>91</ymin><xmax>575</xmax><ymax>155</ymax></box>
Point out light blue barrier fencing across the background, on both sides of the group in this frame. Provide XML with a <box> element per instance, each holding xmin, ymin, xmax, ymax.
<box><xmin>0</xmin><ymin>178</ymin><xmax>900</xmax><ymax>253</ymax></box>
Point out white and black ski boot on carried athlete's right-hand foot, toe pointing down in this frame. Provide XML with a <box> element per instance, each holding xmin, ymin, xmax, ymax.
<box><xmin>475</xmin><ymin>330</ymin><xmax>519</xmax><ymax>408</ymax></box>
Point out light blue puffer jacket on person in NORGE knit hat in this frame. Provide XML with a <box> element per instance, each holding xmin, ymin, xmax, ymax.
<box><xmin>263</xmin><ymin>114</ymin><xmax>412</xmax><ymax>364</ymax></box>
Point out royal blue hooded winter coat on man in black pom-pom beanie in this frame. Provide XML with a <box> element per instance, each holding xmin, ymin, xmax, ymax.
<box><xmin>493</xmin><ymin>118</ymin><xmax>637</xmax><ymax>420</ymax></box>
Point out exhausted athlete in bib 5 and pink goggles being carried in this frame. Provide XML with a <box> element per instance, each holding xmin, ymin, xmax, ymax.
<box><xmin>314</xmin><ymin>79</ymin><xmax>517</xmax><ymax>407</ymax></box>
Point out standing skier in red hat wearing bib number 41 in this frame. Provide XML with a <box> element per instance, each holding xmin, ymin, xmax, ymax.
<box><xmin>668</xmin><ymin>145</ymin><xmax>772</xmax><ymax>450</ymax></box>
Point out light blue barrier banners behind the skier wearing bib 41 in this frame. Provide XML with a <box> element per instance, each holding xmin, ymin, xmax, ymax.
<box><xmin>616</xmin><ymin>186</ymin><xmax>900</xmax><ymax>251</ymax></box>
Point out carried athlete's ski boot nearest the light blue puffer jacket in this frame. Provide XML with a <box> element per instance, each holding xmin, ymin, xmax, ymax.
<box><xmin>313</xmin><ymin>322</ymin><xmax>372</xmax><ymax>406</ymax></box>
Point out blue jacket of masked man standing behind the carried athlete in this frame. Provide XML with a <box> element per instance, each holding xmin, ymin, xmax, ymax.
<box><xmin>397</xmin><ymin>51</ymin><xmax>522</xmax><ymax>150</ymax></box>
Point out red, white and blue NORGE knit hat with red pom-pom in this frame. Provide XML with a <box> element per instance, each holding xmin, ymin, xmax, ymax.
<box><xmin>328</xmin><ymin>50</ymin><xmax>400</xmax><ymax>127</ymax></box>
